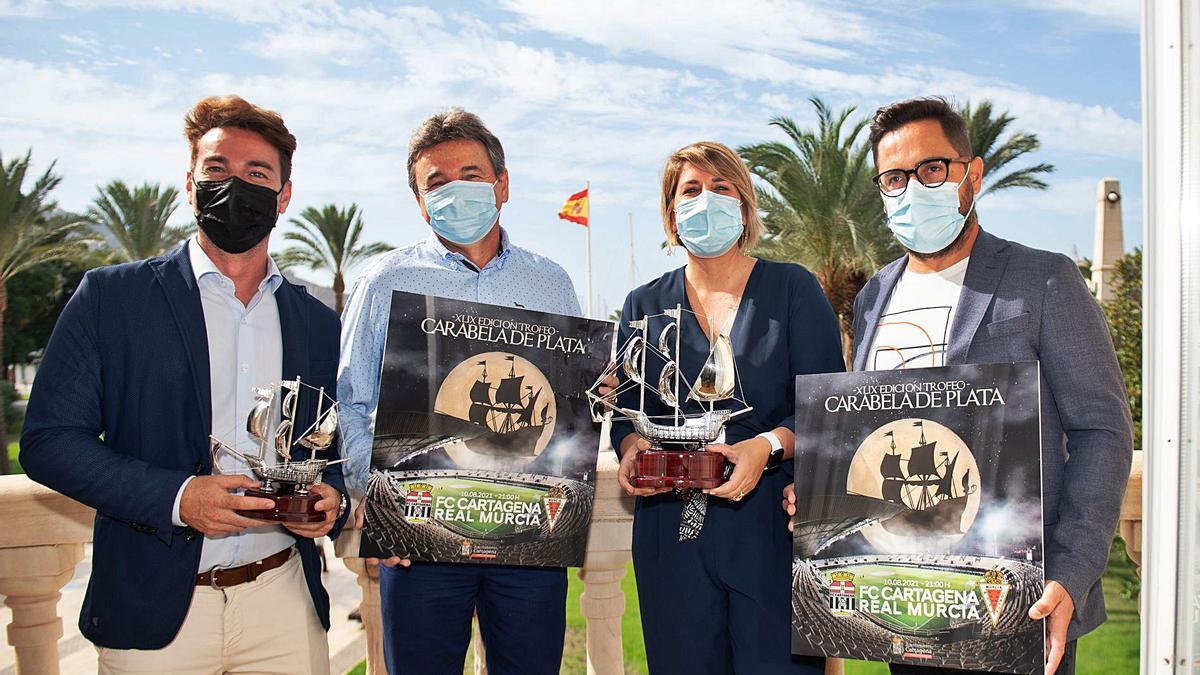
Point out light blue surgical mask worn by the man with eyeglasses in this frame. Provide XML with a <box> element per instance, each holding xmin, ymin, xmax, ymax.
<box><xmin>883</xmin><ymin>180</ymin><xmax>974</xmax><ymax>253</ymax></box>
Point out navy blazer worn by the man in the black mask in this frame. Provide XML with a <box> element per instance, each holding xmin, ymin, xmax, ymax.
<box><xmin>20</xmin><ymin>243</ymin><xmax>346</xmax><ymax>650</ymax></box>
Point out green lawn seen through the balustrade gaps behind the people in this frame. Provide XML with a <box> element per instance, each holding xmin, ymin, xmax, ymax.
<box><xmin>350</xmin><ymin>539</ymin><xmax>1140</xmax><ymax>675</ymax></box>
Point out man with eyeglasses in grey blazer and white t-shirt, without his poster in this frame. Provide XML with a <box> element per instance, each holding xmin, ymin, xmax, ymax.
<box><xmin>784</xmin><ymin>98</ymin><xmax>1133</xmax><ymax>675</ymax></box>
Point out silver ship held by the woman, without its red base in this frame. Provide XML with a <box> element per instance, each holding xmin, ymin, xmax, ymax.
<box><xmin>588</xmin><ymin>305</ymin><xmax>751</xmax><ymax>450</ymax></box>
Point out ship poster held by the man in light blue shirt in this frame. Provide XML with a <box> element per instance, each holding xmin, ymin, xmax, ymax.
<box><xmin>361</xmin><ymin>291</ymin><xmax>613</xmax><ymax>567</ymax></box>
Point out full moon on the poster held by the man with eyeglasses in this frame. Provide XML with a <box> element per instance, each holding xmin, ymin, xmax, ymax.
<box><xmin>846</xmin><ymin>417</ymin><xmax>980</xmax><ymax>552</ymax></box>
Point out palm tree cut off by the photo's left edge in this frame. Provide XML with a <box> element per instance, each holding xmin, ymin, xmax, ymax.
<box><xmin>0</xmin><ymin>151</ymin><xmax>86</xmax><ymax>474</ymax></box>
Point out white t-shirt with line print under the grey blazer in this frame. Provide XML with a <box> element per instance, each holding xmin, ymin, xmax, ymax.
<box><xmin>866</xmin><ymin>257</ymin><xmax>971</xmax><ymax>370</ymax></box>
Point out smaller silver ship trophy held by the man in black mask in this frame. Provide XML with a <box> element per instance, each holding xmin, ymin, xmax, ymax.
<box><xmin>209</xmin><ymin>377</ymin><xmax>346</xmax><ymax>522</ymax></box>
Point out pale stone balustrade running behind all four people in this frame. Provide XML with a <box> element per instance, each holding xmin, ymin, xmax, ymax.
<box><xmin>0</xmin><ymin>452</ymin><xmax>1141</xmax><ymax>675</ymax></box>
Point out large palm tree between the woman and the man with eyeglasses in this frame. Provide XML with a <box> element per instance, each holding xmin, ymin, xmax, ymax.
<box><xmin>738</xmin><ymin>97</ymin><xmax>900</xmax><ymax>352</ymax></box>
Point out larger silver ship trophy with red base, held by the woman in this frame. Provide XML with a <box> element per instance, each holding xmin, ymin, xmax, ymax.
<box><xmin>588</xmin><ymin>305</ymin><xmax>751</xmax><ymax>489</ymax></box>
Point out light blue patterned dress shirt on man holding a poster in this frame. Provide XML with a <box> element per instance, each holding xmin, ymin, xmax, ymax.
<box><xmin>337</xmin><ymin>228</ymin><xmax>582</xmax><ymax>500</ymax></box>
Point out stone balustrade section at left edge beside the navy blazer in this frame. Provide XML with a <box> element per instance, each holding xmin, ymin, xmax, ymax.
<box><xmin>0</xmin><ymin>476</ymin><xmax>95</xmax><ymax>675</ymax></box>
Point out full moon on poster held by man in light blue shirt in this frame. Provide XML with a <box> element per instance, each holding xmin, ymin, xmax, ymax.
<box><xmin>433</xmin><ymin>352</ymin><xmax>558</xmax><ymax>471</ymax></box>
